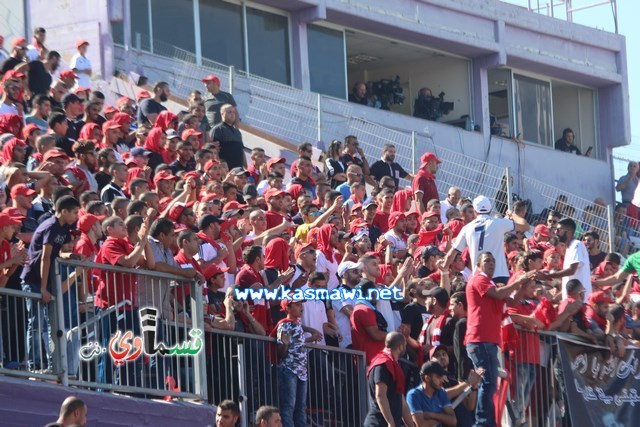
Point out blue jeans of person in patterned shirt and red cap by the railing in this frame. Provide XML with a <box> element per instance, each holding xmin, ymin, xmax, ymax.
<box><xmin>278</xmin><ymin>366</ymin><xmax>307</xmax><ymax>427</ymax></box>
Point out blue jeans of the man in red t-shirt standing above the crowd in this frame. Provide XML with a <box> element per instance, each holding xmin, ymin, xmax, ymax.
<box><xmin>467</xmin><ymin>342</ymin><xmax>498</xmax><ymax>427</ymax></box>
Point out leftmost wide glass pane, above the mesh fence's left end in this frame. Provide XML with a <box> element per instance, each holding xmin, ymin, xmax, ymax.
<box><xmin>151</xmin><ymin>0</ymin><xmax>196</xmax><ymax>56</ymax></box>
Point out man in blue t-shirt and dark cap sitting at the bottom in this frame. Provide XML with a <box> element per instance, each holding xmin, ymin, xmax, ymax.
<box><xmin>407</xmin><ymin>361</ymin><xmax>458</xmax><ymax>427</ymax></box>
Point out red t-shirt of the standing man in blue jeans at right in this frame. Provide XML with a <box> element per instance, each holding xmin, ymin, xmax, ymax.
<box><xmin>464</xmin><ymin>271</ymin><xmax>504</xmax><ymax>345</ymax></box>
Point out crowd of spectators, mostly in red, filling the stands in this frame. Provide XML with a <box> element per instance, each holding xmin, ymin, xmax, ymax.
<box><xmin>0</xmin><ymin>31</ymin><xmax>640</xmax><ymax>427</ymax></box>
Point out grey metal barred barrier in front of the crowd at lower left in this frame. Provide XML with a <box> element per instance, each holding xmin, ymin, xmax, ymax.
<box><xmin>0</xmin><ymin>259</ymin><xmax>367</xmax><ymax>426</ymax></box>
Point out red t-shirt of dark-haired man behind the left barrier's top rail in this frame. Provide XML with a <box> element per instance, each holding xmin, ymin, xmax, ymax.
<box><xmin>95</xmin><ymin>237</ymin><xmax>136</xmax><ymax>311</ymax></box>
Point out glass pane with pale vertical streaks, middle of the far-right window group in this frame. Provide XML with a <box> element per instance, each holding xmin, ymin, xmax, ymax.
<box><xmin>513</xmin><ymin>74</ymin><xmax>553</xmax><ymax>147</ymax></box>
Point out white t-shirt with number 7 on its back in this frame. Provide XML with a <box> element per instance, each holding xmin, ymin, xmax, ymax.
<box><xmin>453</xmin><ymin>215</ymin><xmax>515</xmax><ymax>277</ymax></box>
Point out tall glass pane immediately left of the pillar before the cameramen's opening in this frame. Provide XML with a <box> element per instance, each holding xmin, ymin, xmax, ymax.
<box><xmin>247</xmin><ymin>8</ymin><xmax>291</xmax><ymax>85</ymax></box>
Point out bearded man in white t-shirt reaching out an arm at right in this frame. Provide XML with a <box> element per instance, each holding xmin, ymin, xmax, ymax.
<box><xmin>540</xmin><ymin>218</ymin><xmax>592</xmax><ymax>300</ymax></box>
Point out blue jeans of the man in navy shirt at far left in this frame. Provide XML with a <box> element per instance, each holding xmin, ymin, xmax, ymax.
<box><xmin>22</xmin><ymin>282</ymin><xmax>53</xmax><ymax>371</ymax></box>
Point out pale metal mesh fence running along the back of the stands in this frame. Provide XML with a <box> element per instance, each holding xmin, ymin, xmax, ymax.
<box><xmin>114</xmin><ymin>35</ymin><xmax>613</xmax><ymax>250</ymax></box>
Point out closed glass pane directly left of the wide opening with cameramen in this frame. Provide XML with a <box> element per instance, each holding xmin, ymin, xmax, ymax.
<box><xmin>307</xmin><ymin>25</ymin><xmax>347</xmax><ymax>99</ymax></box>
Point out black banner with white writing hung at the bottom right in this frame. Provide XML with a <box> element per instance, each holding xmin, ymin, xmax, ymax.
<box><xmin>558</xmin><ymin>337</ymin><xmax>640</xmax><ymax>427</ymax></box>
